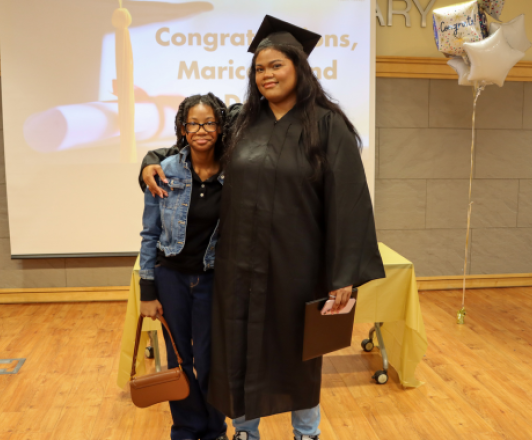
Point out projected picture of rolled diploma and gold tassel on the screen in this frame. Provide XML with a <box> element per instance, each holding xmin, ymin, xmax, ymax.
<box><xmin>23</xmin><ymin>0</ymin><xmax>213</xmax><ymax>163</ymax></box>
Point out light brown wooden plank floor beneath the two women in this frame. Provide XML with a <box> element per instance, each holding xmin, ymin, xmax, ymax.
<box><xmin>0</xmin><ymin>288</ymin><xmax>532</xmax><ymax>440</ymax></box>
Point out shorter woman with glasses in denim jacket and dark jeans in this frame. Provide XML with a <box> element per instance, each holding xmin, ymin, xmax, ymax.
<box><xmin>140</xmin><ymin>93</ymin><xmax>227</xmax><ymax>440</ymax></box>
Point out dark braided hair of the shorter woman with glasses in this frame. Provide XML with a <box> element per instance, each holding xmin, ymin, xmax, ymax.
<box><xmin>174</xmin><ymin>93</ymin><xmax>227</xmax><ymax>160</ymax></box>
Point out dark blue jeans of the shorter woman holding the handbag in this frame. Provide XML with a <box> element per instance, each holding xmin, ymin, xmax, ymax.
<box><xmin>155</xmin><ymin>266</ymin><xmax>227</xmax><ymax>440</ymax></box>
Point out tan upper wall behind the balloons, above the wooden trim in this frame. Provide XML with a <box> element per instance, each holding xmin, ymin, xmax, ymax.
<box><xmin>377</xmin><ymin>0</ymin><xmax>532</xmax><ymax>61</ymax></box>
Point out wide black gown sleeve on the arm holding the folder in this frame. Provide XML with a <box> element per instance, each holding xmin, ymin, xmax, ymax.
<box><xmin>320</xmin><ymin>112</ymin><xmax>386</xmax><ymax>291</ymax></box>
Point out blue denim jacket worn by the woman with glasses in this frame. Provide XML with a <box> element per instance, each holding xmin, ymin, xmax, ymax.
<box><xmin>140</xmin><ymin>146</ymin><xmax>224</xmax><ymax>280</ymax></box>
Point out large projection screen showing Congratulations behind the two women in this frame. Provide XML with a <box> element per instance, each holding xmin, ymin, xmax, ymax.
<box><xmin>0</xmin><ymin>0</ymin><xmax>375</xmax><ymax>258</ymax></box>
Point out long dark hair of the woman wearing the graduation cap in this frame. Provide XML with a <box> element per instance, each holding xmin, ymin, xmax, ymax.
<box><xmin>226</xmin><ymin>38</ymin><xmax>362</xmax><ymax>178</ymax></box>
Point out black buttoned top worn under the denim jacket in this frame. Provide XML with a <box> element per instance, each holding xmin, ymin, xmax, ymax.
<box><xmin>140</xmin><ymin>162</ymin><xmax>222</xmax><ymax>301</ymax></box>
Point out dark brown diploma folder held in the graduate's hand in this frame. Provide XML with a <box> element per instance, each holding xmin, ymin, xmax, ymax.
<box><xmin>303</xmin><ymin>298</ymin><xmax>356</xmax><ymax>361</ymax></box>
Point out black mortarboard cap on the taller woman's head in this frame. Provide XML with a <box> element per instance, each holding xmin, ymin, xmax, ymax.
<box><xmin>248</xmin><ymin>15</ymin><xmax>321</xmax><ymax>55</ymax></box>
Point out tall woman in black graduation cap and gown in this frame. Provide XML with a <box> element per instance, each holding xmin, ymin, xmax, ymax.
<box><xmin>139</xmin><ymin>16</ymin><xmax>385</xmax><ymax>440</ymax></box>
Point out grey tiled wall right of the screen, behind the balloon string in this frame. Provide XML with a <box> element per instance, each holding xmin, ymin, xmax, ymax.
<box><xmin>375</xmin><ymin>78</ymin><xmax>532</xmax><ymax>276</ymax></box>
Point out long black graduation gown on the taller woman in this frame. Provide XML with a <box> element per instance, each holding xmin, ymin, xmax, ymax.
<box><xmin>139</xmin><ymin>103</ymin><xmax>385</xmax><ymax>420</ymax></box>
